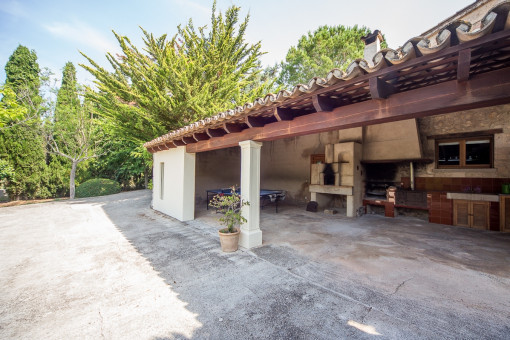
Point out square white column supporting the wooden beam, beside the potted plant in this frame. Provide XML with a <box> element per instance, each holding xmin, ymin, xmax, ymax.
<box><xmin>239</xmin><ymin>140</ymin><xmax>262</xmax><ymax>249</ymax></box>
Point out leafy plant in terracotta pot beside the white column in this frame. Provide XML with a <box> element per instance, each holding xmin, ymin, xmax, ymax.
<box><xmin>209</xmin><ymin>186</ymin><xmax>250</xmax><ymax>252</ymax></box>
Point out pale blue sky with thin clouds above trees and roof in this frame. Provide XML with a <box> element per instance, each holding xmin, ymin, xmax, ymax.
<box><xmin>0</xmin><ymin>0</ymin><xmax>473</xmax><ymax>84</ymax></box>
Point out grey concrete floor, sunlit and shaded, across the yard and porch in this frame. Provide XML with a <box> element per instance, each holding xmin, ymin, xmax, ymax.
<box><xmin>0</xmin><ymin>191</ymin><xmax>510</xmax><ymax>339</ymax></box>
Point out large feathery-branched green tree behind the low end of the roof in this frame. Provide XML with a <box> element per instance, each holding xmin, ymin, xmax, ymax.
<box><xmin>81</xmin><ymin>2</ymin><xmax>272</xmax><ymax>143</ymax></box>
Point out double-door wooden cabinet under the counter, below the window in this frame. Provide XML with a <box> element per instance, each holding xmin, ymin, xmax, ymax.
<box><xmin>453</xmin><ymin>200</ymin><xmax>490</xmax><ymax>230</ymax></box>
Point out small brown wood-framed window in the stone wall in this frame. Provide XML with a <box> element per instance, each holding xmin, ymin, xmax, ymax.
<box><xmin>436</xmin><ymin>136</ymin><xmax>493</xmax><ymax>169</ymax></box>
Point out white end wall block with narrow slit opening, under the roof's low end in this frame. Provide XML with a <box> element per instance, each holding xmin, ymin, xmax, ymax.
<box><xmin>152</xmin><ymin>146</ymin><xmax>195</xmax><ymax>221</ymax></box>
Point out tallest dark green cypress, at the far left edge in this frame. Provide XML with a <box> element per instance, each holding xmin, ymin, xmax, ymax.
<box><xmin>0</xmin><ymin>45</ymin><xmax>50</xmax><ymax>199</ymax></box>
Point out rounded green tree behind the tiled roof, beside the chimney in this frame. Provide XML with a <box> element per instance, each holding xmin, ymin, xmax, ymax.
<box><xmin>277</xmin><ymin>25</ymin><xmax>386</xmax><ymax>86</ymax></box>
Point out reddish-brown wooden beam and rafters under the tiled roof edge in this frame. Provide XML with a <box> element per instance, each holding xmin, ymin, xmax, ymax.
<box><xmin>144</xmin><ymin>25</ymin><xmax>510</xmax><ymax>152</ymax></box>
